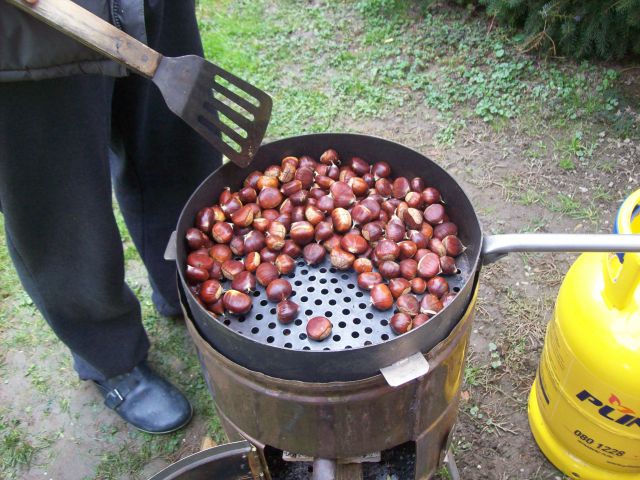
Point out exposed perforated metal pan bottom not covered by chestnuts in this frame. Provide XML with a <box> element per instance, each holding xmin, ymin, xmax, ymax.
<box><xmin>222</xmin><ymin>259</ymin><xmax>466</xmax><ymax>350</ymax></box>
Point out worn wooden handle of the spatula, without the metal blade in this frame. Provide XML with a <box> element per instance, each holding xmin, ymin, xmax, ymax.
<box><xmin>6</xmin><ymin>0</ymin><xmax>161</xmax><ymax>78</ymax></box>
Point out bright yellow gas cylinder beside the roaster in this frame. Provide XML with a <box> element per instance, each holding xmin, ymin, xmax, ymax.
<box><xmin>529</xmin><ymin>190</ymin><xmax>640</xmax><ymax>480</ymax></box>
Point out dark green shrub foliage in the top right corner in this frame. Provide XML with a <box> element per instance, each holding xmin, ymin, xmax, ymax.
<box><xmin>480</xmin><ymin>0</ymin><xmax>640</xmax><ymax>59</ymax></box>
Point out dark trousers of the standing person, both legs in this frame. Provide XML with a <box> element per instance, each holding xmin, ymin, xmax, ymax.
<box><xmin>0</xmin><ymin>0</ymin><xmax>221</xmax><ymax>380</ymax></box>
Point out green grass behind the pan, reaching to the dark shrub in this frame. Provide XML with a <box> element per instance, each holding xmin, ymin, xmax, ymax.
<box><xmin>199</xmin><ymin>0</ymin><xmax>637</xmax><ymax>147</ymax></box>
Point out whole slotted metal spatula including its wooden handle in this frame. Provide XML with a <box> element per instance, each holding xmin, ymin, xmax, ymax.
<box><xmin>7</xmin><ymin>0</ymin><xmax>272</xmax><ymax>167</ymax></box>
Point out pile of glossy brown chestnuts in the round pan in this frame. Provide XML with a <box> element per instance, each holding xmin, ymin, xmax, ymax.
<box><xmin>185</xmin><ymin>149</ymin><xmax>464</xmax><ymax>341</ymax></box>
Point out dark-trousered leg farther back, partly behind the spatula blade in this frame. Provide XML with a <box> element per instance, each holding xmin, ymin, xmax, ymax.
<box><xmin>112</xmin><ymin>0</ymin><xmax>221</xmax><ymax>316</ymax></box>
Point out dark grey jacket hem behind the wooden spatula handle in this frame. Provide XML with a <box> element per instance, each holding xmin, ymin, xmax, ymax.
<box><xmin>0</xmin><ymin>0</ymin><xmax>146</xmax><ymax>82</ymax></box>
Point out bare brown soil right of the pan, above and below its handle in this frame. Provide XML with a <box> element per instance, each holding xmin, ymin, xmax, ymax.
<box><xmin>336</xmin><ymin>103</ymin><xmax>640</xmax><ymax>480</ymax></box>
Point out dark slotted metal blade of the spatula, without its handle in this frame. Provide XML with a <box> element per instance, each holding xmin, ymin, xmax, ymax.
<box><xmin>152</xmin><ymin>55</ymin><xmax>272</xmax><ymax>167</ymax></box>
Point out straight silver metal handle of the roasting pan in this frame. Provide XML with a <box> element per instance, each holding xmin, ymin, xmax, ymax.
<box><xmin>482</xmin><ymin>233</ymin><xmax>640</xmax><ymax>265</ymax></box>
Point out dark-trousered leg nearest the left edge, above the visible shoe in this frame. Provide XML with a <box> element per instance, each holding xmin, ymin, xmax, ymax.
<box><xmin>0</xmin><ymin>76</ymin><xmax>149</xmax><ymax>380</ymax></box>
